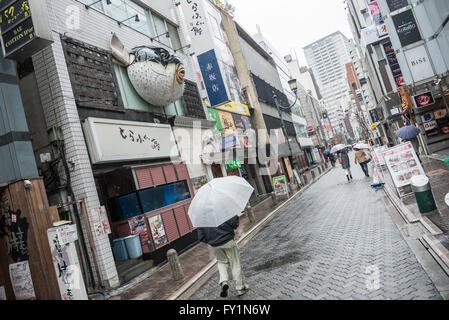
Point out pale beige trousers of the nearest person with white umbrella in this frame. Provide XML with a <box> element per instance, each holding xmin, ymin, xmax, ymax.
<box><xmin>213</xmin><ymin>240</ymin><xmax>245</xmax><ymax>290</ymax></box>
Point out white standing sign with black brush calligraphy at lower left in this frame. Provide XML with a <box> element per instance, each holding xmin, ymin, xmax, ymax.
<box><xmin>47</xmin><ymin>227</ymin><xmax>88</xmax><ymax>301</ymax></box>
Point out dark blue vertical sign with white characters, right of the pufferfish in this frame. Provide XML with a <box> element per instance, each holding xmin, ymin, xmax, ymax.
<box><xmin>198</xmin><ymin>49</ymin><xmax>229</xmax><ymax>107</ymax></box>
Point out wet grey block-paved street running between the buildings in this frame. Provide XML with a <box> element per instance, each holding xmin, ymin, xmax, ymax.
<box><xmin>190</xmin><ymin>153</ymin><xmax>442</xmax><ymax>300</ymax></box>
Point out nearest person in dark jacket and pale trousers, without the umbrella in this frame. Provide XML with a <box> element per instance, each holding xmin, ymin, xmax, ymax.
<box><xmin>198</xmin><ymin>216</ymin><xmax>249</xmax><ymax>298</ymax></box>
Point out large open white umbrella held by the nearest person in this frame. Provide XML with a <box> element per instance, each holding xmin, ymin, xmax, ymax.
<box><xmin>188</xmin><ymin>176</ymin><xmax>254</xmax><ymax>228</ymax></box>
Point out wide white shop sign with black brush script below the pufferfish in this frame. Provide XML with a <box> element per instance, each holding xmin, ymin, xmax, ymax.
<box><xmin>83</xmin><ymin>118</ymin><xmax>179</xmax><ymax>164</ymax></box>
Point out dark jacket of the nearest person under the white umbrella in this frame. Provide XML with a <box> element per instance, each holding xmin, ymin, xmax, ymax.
<box><xmin>198</xmin><ymin>216</ymin><xmax>240</xmax><ymax>247</ymax></box>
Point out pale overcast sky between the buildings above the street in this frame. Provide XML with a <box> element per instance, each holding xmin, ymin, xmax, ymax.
<box><xmin>228</xmin><ymin>0</ymin><xmax>352</xmax><ymax>65</ymax></box>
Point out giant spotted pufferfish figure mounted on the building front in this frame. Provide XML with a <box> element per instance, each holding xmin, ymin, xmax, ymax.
<box><xmin>111</xmin><ymin>33</ymin><xmax>185</xmax><ymax>107</ymax></box>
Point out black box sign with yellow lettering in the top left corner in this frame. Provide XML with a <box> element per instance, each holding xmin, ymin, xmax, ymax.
<box><xmin>0</xmin><ymin>0</ymin><xmax>53</xmax><ymax>60</ymax></box>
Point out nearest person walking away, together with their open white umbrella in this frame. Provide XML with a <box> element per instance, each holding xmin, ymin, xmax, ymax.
<box><xmin>188</xmin><ymin>176</ymin><xmax>254</xmax><ymax>298</ymax></box>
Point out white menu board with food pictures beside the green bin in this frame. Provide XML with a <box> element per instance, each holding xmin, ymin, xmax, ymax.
<box><xmin>383</xmin><ymin>142</ymin><xmax>426</xmax><ymax>188</ymax></box>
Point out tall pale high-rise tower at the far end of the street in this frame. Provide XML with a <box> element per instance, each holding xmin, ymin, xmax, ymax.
<box><xmin>304</xmin><ymin>31</ymin><xmax>355</xmax><ymax>132</ymax></box>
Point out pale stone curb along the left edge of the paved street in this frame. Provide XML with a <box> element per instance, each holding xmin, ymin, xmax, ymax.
<box><xmin>167</xmin><ymin>168</ymin><xmax>332</xmax><ymax>300</ymax></box>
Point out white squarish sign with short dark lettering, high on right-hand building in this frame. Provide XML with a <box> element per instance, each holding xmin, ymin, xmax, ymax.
<box><xmin>404</xmin><ymin>45</ymin><xmax>435</xmax><ymax>82</ymax></box>
